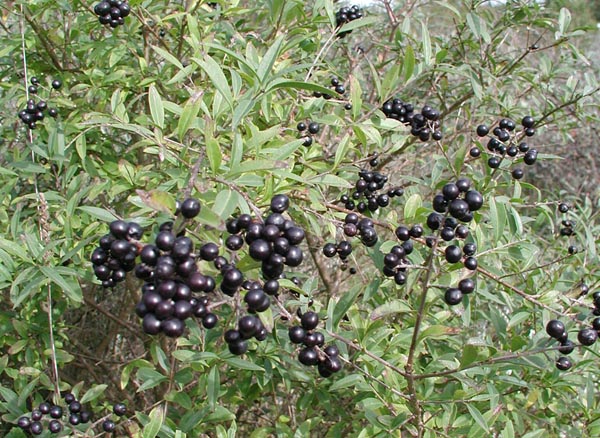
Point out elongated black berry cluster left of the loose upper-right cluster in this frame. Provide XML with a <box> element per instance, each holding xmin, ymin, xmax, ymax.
<box><xmin>381</xmin><ymin>98</ymin><xmax>442</xmax><ymax>141</ymax></box>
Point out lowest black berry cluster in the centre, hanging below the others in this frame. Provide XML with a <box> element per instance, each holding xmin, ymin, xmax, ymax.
<box><xmin>288</xmin><ymin>311</ymin><xmax>342</xmax><ymax>377</ymax></box>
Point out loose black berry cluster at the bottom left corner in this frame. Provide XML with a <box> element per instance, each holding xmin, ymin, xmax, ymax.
<box><xmin>17</xmin><ymin>393</ymin><xmax>120</xmax><ymax>435</ymax></box>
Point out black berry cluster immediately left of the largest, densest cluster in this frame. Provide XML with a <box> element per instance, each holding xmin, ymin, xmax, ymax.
<box><xmin>91</xmin><ymin>220</ymin><xmax>144</xmax><ymax>287</ymax></box>
